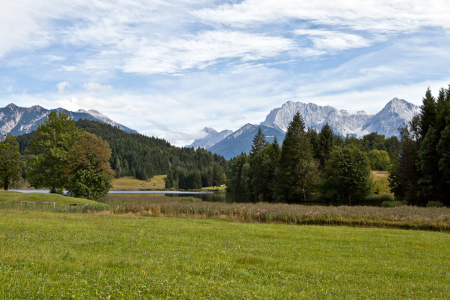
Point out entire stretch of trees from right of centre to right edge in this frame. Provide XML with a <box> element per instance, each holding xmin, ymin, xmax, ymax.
<box><xmin>227</xmin><ymin>87</ymin><xmax>450</xmax><ymax>206</ymax></box>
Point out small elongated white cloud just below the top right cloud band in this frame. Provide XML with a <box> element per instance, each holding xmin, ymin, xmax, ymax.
<box><xmin>294</xmin><ymin>29</ymin><xmax>371</xmax><ymax>51</ymax></box>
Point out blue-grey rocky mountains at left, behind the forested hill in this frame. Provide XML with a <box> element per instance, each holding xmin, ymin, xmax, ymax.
<box><xmin>0</xmin><ymin>103</ymin><xmax>137</xmax><ymax>136</ymax></box>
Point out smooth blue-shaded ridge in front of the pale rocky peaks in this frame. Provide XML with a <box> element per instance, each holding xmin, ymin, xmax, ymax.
<box><xmin>208</xmin><ymin>124</ymin><xmax>286</xmax><ymax>159</ymax></box>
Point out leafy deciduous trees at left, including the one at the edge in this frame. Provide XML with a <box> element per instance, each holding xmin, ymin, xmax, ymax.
<box><xmin>0</xmin><ymin>112</ymin><xmax>114</xmax><ymax>199</ymax></box>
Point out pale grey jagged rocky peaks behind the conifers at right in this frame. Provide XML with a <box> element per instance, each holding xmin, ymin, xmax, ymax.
<box><xmin>261</xmin><ymin>98</ymin><xmax>420</xmax><ymax>137</ymax></box>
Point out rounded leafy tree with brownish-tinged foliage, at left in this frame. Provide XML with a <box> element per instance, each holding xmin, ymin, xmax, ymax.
<box><xmin>64</xmin><ymin>132</ymin><xmax>114</xmax><ymax>199</ymax></box>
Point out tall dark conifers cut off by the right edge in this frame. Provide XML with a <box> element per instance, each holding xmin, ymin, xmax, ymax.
<box><xmin>389</xmin><ymin>86</ymin><xmax>450</xmax><ymax>206</ymax></box>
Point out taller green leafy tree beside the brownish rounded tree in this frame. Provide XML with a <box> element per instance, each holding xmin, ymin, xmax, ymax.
<box><xmin>27</xmin><ymin>111</ymin><xmax>80</xmax><ymax>193</ymax></box>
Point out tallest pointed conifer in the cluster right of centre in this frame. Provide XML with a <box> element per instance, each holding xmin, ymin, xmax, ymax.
<box><xmin>274</xmin><ymin>112</ymin><xmax>318</xmax><ymax>203</ymax></box>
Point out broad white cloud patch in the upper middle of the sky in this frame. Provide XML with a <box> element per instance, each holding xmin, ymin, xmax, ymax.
<box><xmin>123</xmin><ymin>31</ymin><xmax>293</xmax><ymax>74</ymax></box>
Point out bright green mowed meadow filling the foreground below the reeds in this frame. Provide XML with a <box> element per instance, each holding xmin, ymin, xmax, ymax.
<box><xmin>0</xmin><ymin>210</ymin><xmax>450</xmax><ymax>299</ymax></box>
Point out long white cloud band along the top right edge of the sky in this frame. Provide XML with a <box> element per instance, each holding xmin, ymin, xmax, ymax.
<box><xmin>192</xmin><ymin>0</ymin><xmax>450</xmax><ymax>32</ymax></box>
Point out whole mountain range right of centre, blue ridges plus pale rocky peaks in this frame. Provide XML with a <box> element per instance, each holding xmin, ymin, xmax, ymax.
<box><xmin>191</xmin><ymin>98</ymin><xmax>420</xmax><ymax>159</ymax></box>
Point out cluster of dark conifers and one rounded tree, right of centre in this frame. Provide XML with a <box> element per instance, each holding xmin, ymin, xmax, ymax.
<box><xmin>228</xmin><ymin>113</ymin><xmax>371</xmax><ymax>203</ymax></box>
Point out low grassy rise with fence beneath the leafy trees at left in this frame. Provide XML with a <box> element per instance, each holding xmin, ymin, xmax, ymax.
<box><xmin>0</xmin><ymin>190</ymin><xmax>98</xmax><ymax>205</ymax></box>
